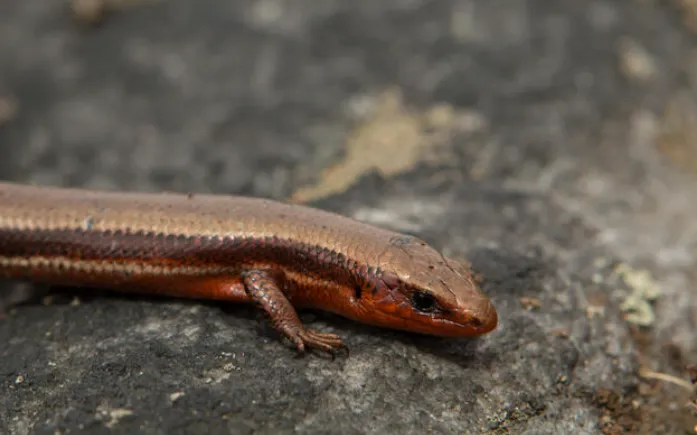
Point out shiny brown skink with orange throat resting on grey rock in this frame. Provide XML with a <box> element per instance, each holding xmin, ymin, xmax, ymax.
<box><xmin>0</xmin><ymin>183</ymin><xmax>498</xmax><ymax>352</ymax></box>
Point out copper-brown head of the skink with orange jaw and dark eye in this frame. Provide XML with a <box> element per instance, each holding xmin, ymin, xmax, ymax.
<box><xmin>356</xmin><ymin>236</ymin><xmax>498</xmax><ymax>337</ymax></box>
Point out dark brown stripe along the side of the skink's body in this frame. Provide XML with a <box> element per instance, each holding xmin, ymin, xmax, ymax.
<box><xmin>0</xmin><ymin>229</ymin><xmax>379</xmax><ymax>297</ymax></box>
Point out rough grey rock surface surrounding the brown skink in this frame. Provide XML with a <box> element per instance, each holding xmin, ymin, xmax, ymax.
<box><xmin>0</xmin><ymin>0</ymin><xmax>697</xmax><ymax>434</ymax></box>
